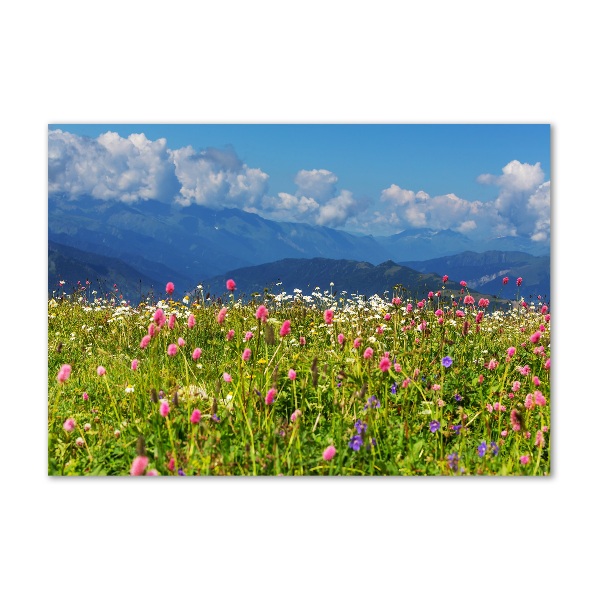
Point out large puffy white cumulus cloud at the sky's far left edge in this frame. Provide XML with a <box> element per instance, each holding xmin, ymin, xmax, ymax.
<box><xmin>48</xmin><ymin>129</ymin><xmax>178</xmax><ymax>202</ymax></box>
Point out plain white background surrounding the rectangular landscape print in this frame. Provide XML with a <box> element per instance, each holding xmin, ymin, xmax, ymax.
<box><xmin>0</xmin><ymin>0</ymin><xmax>600</xmax><ymax>600</ymax></box>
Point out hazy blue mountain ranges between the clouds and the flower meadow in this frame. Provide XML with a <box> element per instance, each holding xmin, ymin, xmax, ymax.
<box><xmin>48</xmin><ymin>195</ymin><xmax>550</xmax><ymax>299</ymax></box>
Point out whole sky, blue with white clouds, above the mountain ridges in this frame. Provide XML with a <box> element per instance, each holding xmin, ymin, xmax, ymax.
<box><xmin>49</xmin><ymin>124</ymin><xmax>550</xmax><ymax>242</ymax></box>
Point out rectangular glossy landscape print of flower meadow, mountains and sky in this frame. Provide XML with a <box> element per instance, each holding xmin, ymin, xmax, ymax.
<box><xmin>48</xmin><ymin>124</ymin><xmax>551</xmax><ymax>477</ymax></box>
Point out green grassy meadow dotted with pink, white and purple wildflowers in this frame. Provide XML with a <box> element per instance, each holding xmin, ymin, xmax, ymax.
<box><xmin>48</xmin><ymin>282</ymin><xmax>550</xmax><ymax>476</ymax></box>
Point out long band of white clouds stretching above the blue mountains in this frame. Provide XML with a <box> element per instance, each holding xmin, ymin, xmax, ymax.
<box><xmin>48</xmin><ymin>130</ymin><xmax>550</xmax><ymax>243</ymax></box>
